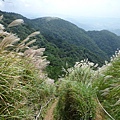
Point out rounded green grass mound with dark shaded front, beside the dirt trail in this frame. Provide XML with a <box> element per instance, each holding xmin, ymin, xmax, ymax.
<box><xmin>54</xmin><ymin>81</ymin><xmax>96</xmax><ymax>120</ymax></box>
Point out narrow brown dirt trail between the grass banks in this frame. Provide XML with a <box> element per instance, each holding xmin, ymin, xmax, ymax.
<box><xmin>44</xmin><ymin>100</ymin><xmax>58</xmax><ymax>120</ymax></box>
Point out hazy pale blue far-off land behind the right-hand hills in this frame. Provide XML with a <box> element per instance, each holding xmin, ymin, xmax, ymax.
<box><xmin>66</xmin><ymin>17</ymin><xmax>120</xmax><ymax>36</ymax></box>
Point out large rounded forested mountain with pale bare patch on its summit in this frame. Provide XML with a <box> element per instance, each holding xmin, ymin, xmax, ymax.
<box><xmin>30</xmin><ymin>17</ymin><xmax>106</xmax><ymax>58</ymax></box>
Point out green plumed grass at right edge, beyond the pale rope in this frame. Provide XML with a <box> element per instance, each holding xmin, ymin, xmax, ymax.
<box><xmin>94</xmin><ymin>50</ymin><xmax>120</xmax><ymax>120</ymax></box>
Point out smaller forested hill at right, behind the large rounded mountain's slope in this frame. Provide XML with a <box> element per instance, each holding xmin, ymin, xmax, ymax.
<box><xmin>87</xmin><ymin>30</ymin><xmax>120</xmax><ymax>57</ymax></box>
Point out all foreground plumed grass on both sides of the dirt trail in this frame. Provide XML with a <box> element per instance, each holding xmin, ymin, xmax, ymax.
<box><xmin>0</xmin><ymin>13</ymin><xmax>120</xmax><ymax>120</ymax></box>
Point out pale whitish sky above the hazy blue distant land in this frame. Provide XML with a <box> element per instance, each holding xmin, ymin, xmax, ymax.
<box><xmin>0</xmin><ymin>0</ymin><xmax>120</xmax><ymax>18</ymax></box>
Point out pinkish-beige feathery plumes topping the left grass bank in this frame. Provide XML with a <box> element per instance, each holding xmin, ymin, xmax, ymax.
<box><xmin>0</xmin><ymin>15</ymin><xmax>49</xmax><ymax>77</ymax></box>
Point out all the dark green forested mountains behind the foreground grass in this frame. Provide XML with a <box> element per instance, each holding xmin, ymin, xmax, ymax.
<box><xmin>0</xmin><ymin>11</ymin><xmax>120</xmax><ymax>79</ymax></box>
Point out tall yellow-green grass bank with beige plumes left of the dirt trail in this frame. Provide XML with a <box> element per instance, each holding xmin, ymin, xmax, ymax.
<box><xmin>0</xmin><ymin>16</ymin><xmax>55</xmax><ymax>120</ymax></box>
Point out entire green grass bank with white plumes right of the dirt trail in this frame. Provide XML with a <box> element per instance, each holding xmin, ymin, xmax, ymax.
<box><xmin>54</xmin><ymin>50</ymin><xmax>120</xmax><ymax>120</ymax></box>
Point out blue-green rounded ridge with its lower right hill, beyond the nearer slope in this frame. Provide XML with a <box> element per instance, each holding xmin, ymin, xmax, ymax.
<box><xmin>29</xmin><ymin>17</ymin><xmax>120</xmax><ymax>60</ymax></box>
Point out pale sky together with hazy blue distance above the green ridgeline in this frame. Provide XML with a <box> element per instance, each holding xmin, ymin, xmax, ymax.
<box><xmin>0</xmin><ymin>0</ymin><xmax>120</xmax><ymax>34</ymax></box>
